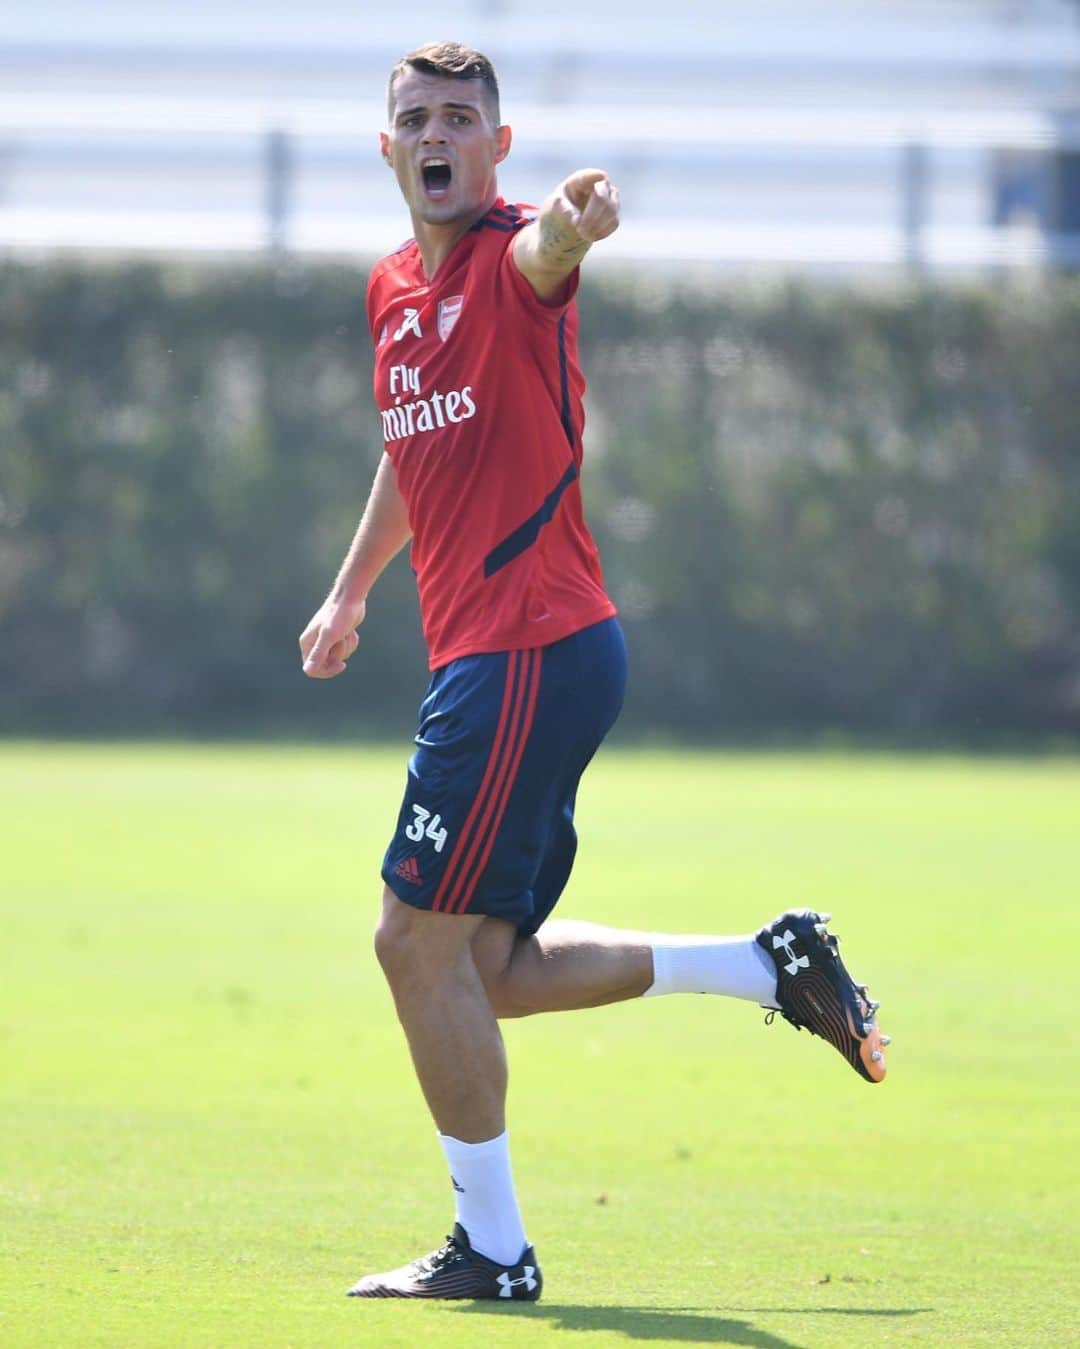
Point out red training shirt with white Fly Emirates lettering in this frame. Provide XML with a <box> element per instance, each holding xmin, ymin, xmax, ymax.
<box><xmin>368</xmin><ymin>197</ymin><xmax>615</xmax><ymax>669</ymax></box>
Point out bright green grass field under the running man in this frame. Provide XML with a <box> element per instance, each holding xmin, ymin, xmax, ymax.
<box><xmin>0</xmin><ymin>745</ymin><xmax>1080</xmax><ymax>1349</ymax></box>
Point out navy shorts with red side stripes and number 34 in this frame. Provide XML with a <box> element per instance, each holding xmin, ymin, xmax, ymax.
<box><xmin>383</xmin><ymin>618</ymin><xmax>626</xmax><ymax>935</ymax></box>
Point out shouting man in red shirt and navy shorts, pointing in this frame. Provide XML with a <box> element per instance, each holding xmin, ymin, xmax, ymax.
<box><xmin>301</xmin><ymin>43</ymin><xmax>887</xmax><ymax>1300</ymax></box>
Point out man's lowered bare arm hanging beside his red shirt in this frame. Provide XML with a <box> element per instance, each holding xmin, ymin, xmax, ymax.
<box><xmin>299</xmin><ymin>453</ymin><xmax>411</xmax><ymax>679</ymax></box>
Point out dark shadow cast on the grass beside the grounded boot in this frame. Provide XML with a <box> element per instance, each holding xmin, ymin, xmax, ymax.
<box><xmin>456</xmin><ymin>1302</ymin><xmax>932</xmax><ymax>1349</ymax></box>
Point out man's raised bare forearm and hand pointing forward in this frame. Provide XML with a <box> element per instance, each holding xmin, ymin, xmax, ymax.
<box><xmin>514</xmin><ymin>169</ymin><xmax>619</xmax><ymax>304</ymax></box>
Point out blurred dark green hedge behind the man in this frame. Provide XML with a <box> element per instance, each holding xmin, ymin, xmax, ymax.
<box><xmin>0</xmin><ymin>263</ymin><xmax>1080</xmax><ymax>742</ymax></box>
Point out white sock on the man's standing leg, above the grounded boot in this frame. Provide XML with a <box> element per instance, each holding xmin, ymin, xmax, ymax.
<box><xmin>438</xmin><ymin>1129</ymin><xmax>529</xmax><ymax>1265</ymax></box>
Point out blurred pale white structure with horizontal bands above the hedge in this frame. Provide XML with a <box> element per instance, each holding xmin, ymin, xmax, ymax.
<box><xmin>0</xmin><ymin>0</ymin><xmax>1080</xmax><ymax>268</ymax></box>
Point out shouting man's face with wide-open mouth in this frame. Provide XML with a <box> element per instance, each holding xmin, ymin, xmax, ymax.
<box><xmin>379</xmin><ymin>69</ymin><xmax>510</xmax><ymax>225</ymax></box>
